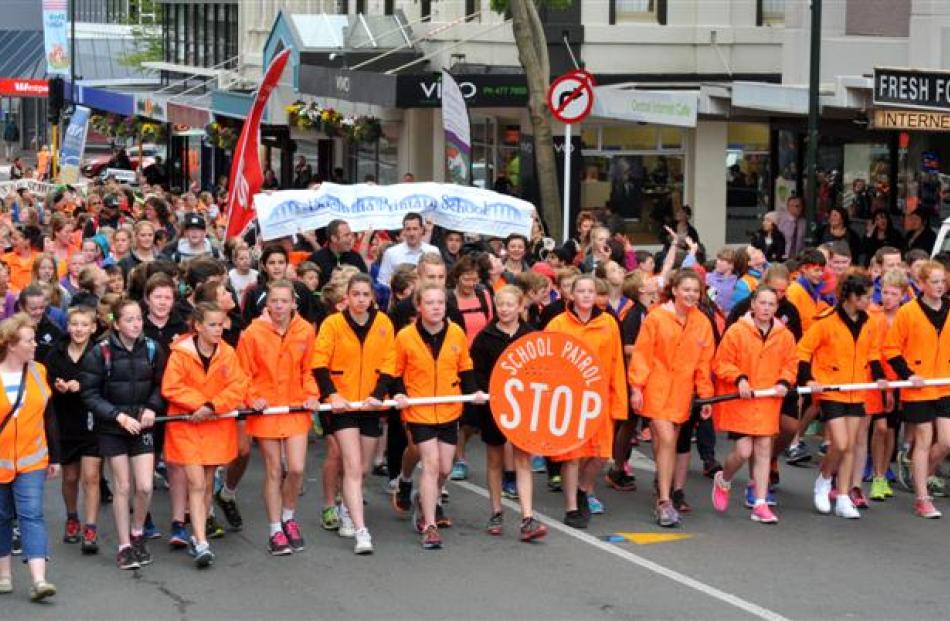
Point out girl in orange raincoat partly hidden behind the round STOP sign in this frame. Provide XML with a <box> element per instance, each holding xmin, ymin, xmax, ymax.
<box><xmin>545</xmin><ymin>275</ymin><xmax>628</xmax><ymax>528</ymax></box>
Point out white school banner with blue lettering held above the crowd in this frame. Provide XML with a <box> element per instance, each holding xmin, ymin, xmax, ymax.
<box><xmin>254</xmin><ymin>183</ymin><xmax>535</xmax><ymax>240</ymax></box>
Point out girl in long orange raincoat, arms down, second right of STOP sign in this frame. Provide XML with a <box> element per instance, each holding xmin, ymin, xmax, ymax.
<box><xmin>628</xmin><ymin>269</ymin><xmax>716</xmax><ymax>528</ymax></box>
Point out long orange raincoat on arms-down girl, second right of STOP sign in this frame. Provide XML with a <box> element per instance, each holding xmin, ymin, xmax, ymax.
<box><xmin>628</xmin><ymin>302</ymin><xmax>716</xmax><ymax>424</ymax></box>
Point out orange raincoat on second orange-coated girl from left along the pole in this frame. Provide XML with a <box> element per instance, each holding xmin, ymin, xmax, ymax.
<box><xmin>237</xmin><ymin>313</ymin><xmax>319</xmax><ymax>439</ymax></box>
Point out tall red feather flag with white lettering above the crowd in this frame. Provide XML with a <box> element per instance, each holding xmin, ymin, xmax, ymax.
<box><xmin>227</xmin><ymin>49</ymin><xmax>290</xmax><ymax>238</ymax></box>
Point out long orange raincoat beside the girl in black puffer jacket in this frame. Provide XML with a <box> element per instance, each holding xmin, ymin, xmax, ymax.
<box><xmin>162</xmin><ymin>334</ymin><xmax>248</xmax><ymax>466</ymax></box>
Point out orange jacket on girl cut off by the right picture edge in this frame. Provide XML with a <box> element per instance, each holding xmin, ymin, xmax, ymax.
<box><xmin>882</xmin><ymin>298</ymin><xmax>950</xmax><ymax>401</ymax></box>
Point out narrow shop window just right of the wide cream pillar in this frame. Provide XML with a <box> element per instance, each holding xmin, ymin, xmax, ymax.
<box><xmin>726</xmin><ymin>123</ymin><xmax>772</xmax><ymax>244</ymax></box>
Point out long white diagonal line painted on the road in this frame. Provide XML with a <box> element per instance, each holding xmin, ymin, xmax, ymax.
<box><xmin>452</xmin><ymin>481</ymin><xmax>789</xmax><ymax>621</ymax></box>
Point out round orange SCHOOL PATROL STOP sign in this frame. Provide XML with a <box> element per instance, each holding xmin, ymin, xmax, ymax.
<box><xmin>490</xmin><ymin>332</ymin><xmax>607</xmax><ymax>456</ymax></box>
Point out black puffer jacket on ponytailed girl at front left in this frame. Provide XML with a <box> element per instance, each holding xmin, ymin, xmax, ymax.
<box><xmin>79</xmin><ymin>333</ymin><xmax>166</xmax><ymax>435</ymax></box>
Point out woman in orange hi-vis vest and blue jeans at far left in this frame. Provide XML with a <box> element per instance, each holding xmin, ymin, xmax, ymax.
<box><xmin>0</xmin><ymin>313</ymin><xmax>59</xmax><ymax>601</ymax></box>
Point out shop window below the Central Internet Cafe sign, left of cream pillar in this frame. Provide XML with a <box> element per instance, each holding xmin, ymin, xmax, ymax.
<box><xmin>581</xmin><ymin>125</ymin><xmax>686</xmax><ymax>244</ymax></box>
